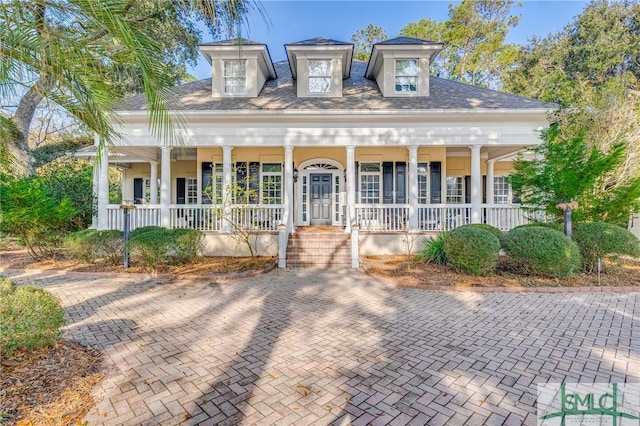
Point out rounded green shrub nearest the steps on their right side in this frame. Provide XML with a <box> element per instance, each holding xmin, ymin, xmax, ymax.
<box><xmin>444</xmin><ymin>226</ymin><xmax>500</xmax><ymax>275</ymax></box>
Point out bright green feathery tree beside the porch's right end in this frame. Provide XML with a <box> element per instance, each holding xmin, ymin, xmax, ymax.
<box><xmin>510</xmin><ymin>123</ymin><xmax>640</xmax><ymax>224</ymax></box>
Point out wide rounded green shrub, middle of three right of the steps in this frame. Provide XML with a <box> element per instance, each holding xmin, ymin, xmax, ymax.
<box><xmin>502</xmin><ymin>226</ymin><xmax>580</xmax><ymax>278</ymax></box>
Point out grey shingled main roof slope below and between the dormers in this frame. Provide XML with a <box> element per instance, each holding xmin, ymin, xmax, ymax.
<box><xmin>117</xmin><ymin>60</ymin><xmax>552</xmax><ymax>111</ymax></box>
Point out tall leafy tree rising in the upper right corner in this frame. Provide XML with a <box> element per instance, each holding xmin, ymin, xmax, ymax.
<box><xmin>503</xmin><ymin>0</ymin><xmax>640</xmax><ymax>208</ymax></box>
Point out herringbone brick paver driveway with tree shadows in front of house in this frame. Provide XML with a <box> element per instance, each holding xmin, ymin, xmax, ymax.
<box><xmin>6</xmin><ymin>270</ymin><xmax>640</xmax><ymax>425</ymax></box>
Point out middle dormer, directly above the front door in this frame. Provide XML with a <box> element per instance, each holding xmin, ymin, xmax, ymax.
<box><xmin>284</xmin><ymin>37</ymin><xmax>353</xmax><ymax>98</ymax></box>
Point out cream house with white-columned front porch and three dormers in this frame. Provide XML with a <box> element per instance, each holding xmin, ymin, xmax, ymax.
<box><xmin>84</xmin><ymin>37</ymin><xmax>548</xmax><ymax>266</ymax></box>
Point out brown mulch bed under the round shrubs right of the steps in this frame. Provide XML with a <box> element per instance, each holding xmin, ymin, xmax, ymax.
<box><xmin>363</xmin><ymin>255</ymin><xmax>640</xmax><ymax>290</ymax></box>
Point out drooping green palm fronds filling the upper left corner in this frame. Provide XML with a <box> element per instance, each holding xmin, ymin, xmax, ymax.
<box><xmin>0</xmin><ymin>0</ymin><xmax>251</xmax><ymax>173</ymax></box>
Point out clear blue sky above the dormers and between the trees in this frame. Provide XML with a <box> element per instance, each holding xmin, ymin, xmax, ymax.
<box><xmin>191</xmin><ymin>0</ymin><xmax>587</xmax><ymax>79</ymax></box>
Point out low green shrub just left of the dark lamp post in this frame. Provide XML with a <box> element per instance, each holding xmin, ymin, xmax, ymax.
<box><xmin>65</xmin><ymin>229</ymin><xmax>124</xmax><ymax>265</ymax></box>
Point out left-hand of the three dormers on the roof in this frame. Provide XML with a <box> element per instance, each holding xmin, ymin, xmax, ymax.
<box><xmin>200</xmin><ymin>39</ymin><xmax>277</xmax><ymax>98</ymax></box>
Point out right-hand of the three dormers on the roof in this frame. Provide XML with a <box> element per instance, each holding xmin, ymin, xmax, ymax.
<box><xmin>364</xmin><ymin>37</ymin><xmax>443</xmax><ymax>98</ymax></box>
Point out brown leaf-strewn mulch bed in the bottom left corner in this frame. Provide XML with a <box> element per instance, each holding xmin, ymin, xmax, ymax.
<box><xmin>0</xmin><ymin>340</ymin><xmax>103</xmax><ymax>426</ymax></box>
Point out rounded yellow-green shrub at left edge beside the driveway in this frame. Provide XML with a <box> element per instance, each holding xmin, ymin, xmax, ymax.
<box><xmin>0</xmin><ymin>279</ymin><xmax>64</xmax><ymax>355</ymax></box>
